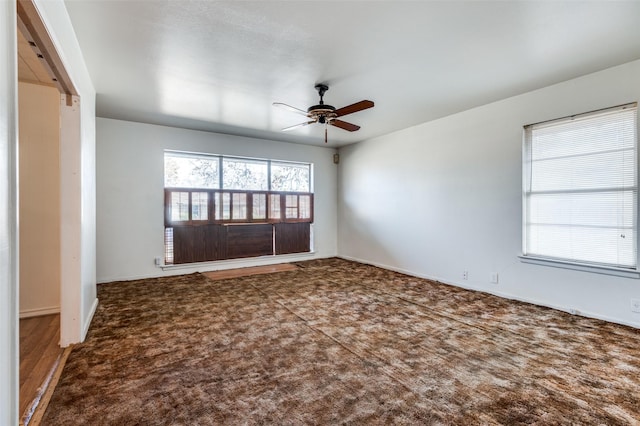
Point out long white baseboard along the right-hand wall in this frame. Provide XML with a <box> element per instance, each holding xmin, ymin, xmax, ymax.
<box><xmin>338</xmin><ymin>255</ymin><xmax>640</xmax><ymax>328</ymax></box>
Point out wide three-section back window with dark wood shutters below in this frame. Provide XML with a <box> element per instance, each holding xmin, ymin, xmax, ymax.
<box><xmin>164</xmin><ymin>151</ymin><xmax>313</xmax><ymax>264</ymax></box>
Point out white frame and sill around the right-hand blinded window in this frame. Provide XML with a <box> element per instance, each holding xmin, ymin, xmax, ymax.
<box><xmin>518</xmin><ymin>102</ymin><xmax>640</xmax><ymax>278</ymax></box>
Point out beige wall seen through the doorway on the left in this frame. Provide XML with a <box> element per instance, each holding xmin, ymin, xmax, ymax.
<box><xmin>18</xmin><ymin>82</ymin><xmax>60</xmax><ymax>318</ymax></box>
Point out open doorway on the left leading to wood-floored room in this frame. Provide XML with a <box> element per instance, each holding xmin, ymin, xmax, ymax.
<box><xmin>17</xmin><ymin>0</ymin><xmax>75</xmax><ymax>425</ymax></box>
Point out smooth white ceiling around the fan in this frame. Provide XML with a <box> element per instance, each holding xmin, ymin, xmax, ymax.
<box><xmin>66</xmin><ymin>0</ymin><xmax>640</xmax><ymax>146</ymax></box>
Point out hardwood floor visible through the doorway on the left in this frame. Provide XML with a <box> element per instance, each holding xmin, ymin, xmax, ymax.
<box><xmin>19</xmin><ymin>314</ymin><xmax>63</xmax><ymax>424</ymax></box>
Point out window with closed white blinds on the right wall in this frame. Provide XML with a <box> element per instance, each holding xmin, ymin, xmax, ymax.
<box><xmin>523</xmin><ymin>103</ymin><xmax>638</xmax><ymax>269</ymax></box>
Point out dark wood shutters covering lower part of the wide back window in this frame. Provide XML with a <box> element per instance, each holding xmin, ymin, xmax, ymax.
<box><xmin>165</xmin><ymin>188</ymin><xmax>313</xmax><ymax>264</ymax></box>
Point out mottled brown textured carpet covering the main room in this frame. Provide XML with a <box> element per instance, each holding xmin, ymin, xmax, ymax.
<box><xmin>43</xmin><ymin>259</ymin><xmax>640</xmax><ymax>425</ymax></box>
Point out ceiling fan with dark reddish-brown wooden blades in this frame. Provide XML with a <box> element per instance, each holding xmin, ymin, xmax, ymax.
<box><xmin>273</xmin><ymin>84</ymin><xmax>374</xmax><ymax>143</ymax></box>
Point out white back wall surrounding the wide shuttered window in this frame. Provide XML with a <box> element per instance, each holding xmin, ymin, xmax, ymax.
<box><xmin>97</xmin><ymin>118</ymin><xmax>337</xmax><ymax>282</ymax></box>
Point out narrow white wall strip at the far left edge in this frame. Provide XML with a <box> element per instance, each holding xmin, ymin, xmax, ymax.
<box><xmin>0</xmin><ymin>1</ymin><xmax>19</xmax><ymax>425</ymax></box>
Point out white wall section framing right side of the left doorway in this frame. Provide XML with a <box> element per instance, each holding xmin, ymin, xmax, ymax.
<box><xmin>33</xmin><ymin>0</ymin><xmax>97</xmax><ymax>346</ymax></box>
